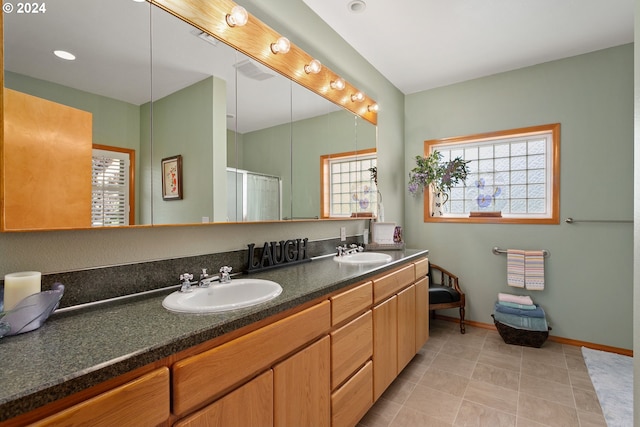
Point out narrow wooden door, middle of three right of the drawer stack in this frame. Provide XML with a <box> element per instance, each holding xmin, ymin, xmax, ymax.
<box><xmin>397</xmin><ymin>285</ymin><xmax>416</xmax><ymax>374</ymax></box>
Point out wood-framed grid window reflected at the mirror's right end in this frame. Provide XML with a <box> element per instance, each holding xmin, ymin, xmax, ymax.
<box><xmin>320</xmin><ymin>148</ymin><xmax>378</xmax><ymax>218</ymax></box>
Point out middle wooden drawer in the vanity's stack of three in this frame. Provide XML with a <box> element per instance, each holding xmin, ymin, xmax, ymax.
<box><xmin>331</xmin><ymin>310</ymin><xmax>373</xmax><ymax>390</ymax></box>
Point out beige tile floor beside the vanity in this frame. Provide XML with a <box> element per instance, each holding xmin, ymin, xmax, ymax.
<box><xmin>358</xmin><ymin>320</ymin><xmax>606</xmax><ymax>427</ymax></box>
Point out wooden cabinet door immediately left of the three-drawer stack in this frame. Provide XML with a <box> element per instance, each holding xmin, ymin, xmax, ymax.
<box><xmin>273</xmin><ymin>336</ymin><xmax>331</xmax><ymax>427</ymax></box>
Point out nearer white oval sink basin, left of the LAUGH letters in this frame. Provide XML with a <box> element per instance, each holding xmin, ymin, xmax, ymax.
<box><xmin>162</xmin><ymin>279</ymin><xmax>282</xmax><ymax>313</ymax></box>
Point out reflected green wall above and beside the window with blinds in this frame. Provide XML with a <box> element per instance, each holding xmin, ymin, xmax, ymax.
<box><xmin>4</xmin><ymin>71</ymin><xmax>140</xmax><ymax>223</ymax></box>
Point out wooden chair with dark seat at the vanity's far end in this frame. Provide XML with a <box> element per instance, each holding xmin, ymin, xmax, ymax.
<box><xmin>429</xmin><ymin>263</ymin><xmax>465</xmax><ymax>334</ymax></box>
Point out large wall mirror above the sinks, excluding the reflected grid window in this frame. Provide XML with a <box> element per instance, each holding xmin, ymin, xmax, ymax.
<box><xmin>3</xmin><ymin>0</ymin><xmax>376</xmax><ymax>230</ymax></box>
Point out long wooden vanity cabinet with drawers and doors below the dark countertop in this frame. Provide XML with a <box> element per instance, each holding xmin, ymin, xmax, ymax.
<box><xmin>10</xmin><ymin>258</ymin><xmax>429</xmax><ymax>427</ymax></box>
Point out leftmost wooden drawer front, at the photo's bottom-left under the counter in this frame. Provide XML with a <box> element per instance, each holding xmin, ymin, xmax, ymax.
<box><xmin>31</xmin><ymin>368</ymin><xmax>170</xmax><ymax>427</ymax></box>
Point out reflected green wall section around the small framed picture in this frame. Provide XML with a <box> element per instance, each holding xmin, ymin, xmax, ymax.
<box><xmin>140</xmin><ymin>77</ymin><xmax>227</xmax><ymax>224</ymax></box>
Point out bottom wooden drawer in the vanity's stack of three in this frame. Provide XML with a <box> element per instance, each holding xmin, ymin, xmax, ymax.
<box><xmin>331</xmin><ymin>361</ymin><xmax>373</xmax><ymax>427</ymax></box>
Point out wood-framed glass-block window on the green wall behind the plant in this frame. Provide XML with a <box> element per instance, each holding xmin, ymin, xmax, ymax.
<box><xmin>424</xmin><ymin>123</ymin><xmax>560</xmax><ymax>224</ymax></box>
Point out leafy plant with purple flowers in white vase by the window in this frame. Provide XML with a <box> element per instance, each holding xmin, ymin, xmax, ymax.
<box><xmin>409</xmin><ymin>151</ymin><xmax>470</xmax><ymax>216</ymax></box>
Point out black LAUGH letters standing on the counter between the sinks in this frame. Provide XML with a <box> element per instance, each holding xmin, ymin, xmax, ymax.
<box><xmin>247</xmin><ymin>237</ymin><xmax>311</xmax><ymax>273</ymax></box>
